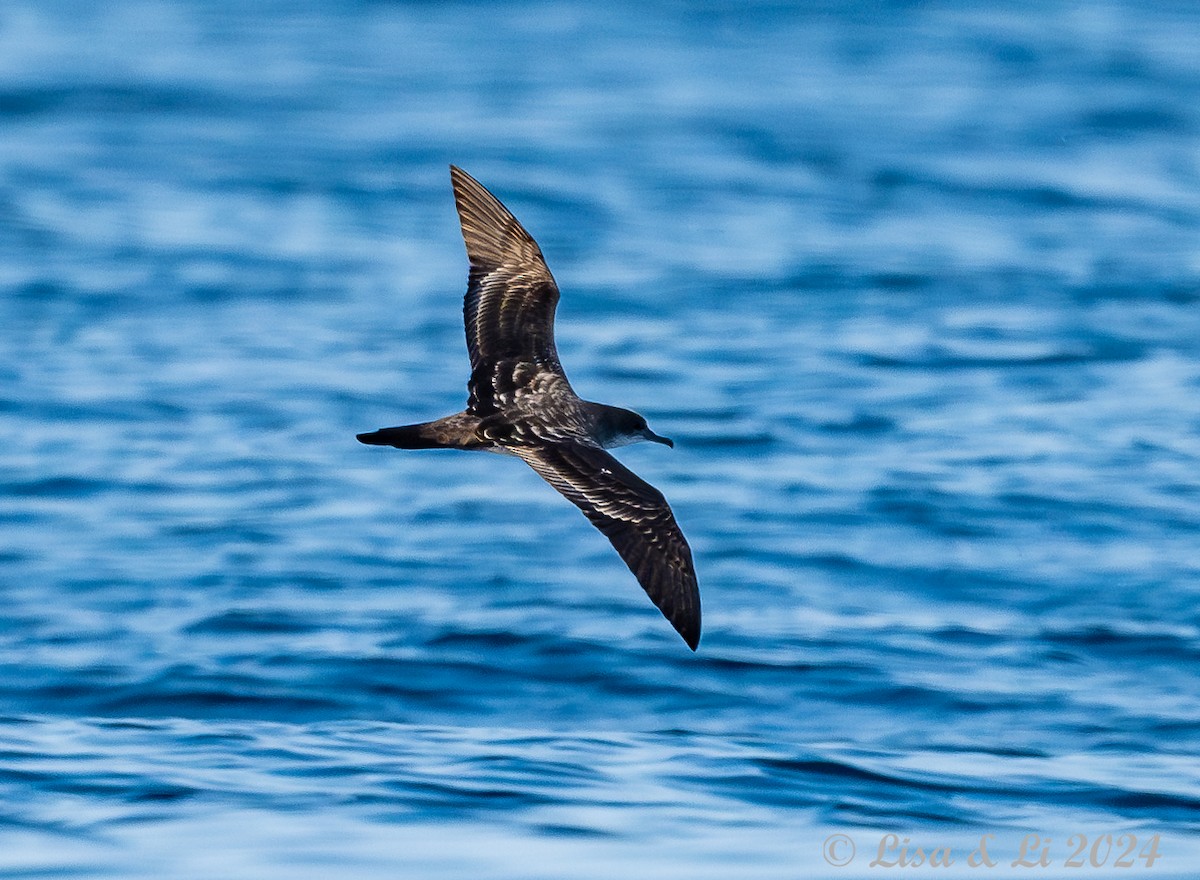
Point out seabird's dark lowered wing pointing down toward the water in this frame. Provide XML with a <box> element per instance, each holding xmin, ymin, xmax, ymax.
<box><xmin>511</xmin><ymin>442</ymin><xmax>700</xmax><ymax>651</ymax></box>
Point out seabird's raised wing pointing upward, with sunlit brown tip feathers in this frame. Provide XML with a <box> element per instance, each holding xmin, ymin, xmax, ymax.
<box><xmin>450</xmin><ymin>166</ymin><xmax>563</xmax><ymax>414</ymax></box>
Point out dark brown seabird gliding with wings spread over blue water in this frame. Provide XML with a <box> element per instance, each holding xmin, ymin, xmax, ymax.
<box><xmin>356</xmin><ymin>164</ymin><xmax>701</xmax><ymax>651</ymax></box>
